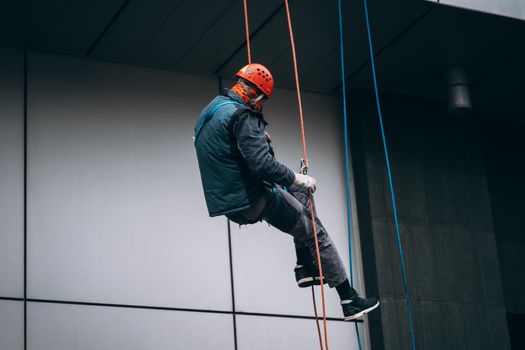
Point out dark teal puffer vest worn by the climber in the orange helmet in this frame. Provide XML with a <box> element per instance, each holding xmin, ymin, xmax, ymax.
<box><xmin>195</xmin><ymin>92</ymin><xmax>263</xmax><ymax>216</ymax></box>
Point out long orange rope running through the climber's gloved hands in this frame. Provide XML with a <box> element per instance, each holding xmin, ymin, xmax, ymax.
<box><xmin>285</xmin><ymin>0</ymin><xmax>328</xmax><ymax>350</ymax></box>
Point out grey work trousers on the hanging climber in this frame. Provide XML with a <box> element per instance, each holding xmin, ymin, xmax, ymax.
<box><xmin>227</xmin><ymin>185</ymin><xmax>348</xmax><ymax>287</ymax></box>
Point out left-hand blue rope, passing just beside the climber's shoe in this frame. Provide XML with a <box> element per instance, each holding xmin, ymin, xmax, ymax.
<box><xmin>338</xmin><ymin>0</ymin><xmax>362</xmax><ymax>350</ymax></box>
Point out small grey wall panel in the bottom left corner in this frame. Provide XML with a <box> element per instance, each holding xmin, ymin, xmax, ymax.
<box><xmin>0</xmin><ymin>300</ymin><xmax>24</xmax><ymax>350</ymax></box>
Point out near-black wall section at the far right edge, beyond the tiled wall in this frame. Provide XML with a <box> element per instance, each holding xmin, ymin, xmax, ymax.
<box><xmin>484</xmin><ymin>119</ymin><xmax>525</xmax><ymax>349</ymax></box>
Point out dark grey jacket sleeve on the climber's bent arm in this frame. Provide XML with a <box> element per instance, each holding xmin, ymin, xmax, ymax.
<box><xmin>233</xmin><ymin>112</ymin><xmax>295</xmax><ymax>186</ymax></box>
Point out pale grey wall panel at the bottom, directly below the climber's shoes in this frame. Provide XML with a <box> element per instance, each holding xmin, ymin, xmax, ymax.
<box><xmin>237</xmin><ymin>316</ymin><xmax>358</xmax><ymax>350</ymax></box>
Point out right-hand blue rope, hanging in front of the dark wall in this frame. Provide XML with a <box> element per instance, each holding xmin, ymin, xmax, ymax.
<box><xmin>363</xmin><ymin>0</ymin><xmax>416</xmax><ymax>350</ymax></box>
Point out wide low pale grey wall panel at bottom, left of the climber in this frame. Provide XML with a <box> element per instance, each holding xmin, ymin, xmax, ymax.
<box><xmin>28</xmin><ymin>303</ymin><xmax>234</xmax><ymax>350</ymax></box>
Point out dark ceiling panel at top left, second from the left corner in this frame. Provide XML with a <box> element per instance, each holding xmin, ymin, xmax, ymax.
<box><xmin>37</xmin><ymin>0</ymin><xmax>126</xmax><ymax>54</ymax></box>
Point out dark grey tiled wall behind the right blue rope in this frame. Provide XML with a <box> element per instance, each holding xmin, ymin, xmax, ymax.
<box><xmin>350</xmin><ymin>90</ymin><xmax>510</xmax><ymax>350</ymax></box>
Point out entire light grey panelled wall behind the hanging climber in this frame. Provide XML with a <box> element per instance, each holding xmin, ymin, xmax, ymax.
<box><xmin>0</xmin><ymin>48</ymin><xmax>366</xmax><ymax>350</ymax></box>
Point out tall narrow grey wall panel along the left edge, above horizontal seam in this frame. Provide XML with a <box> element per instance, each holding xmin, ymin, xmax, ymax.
<box><xmin>0</xmin><ymin>48</ymin><xmax>24</xmax><ymax>297</ymax></box>
